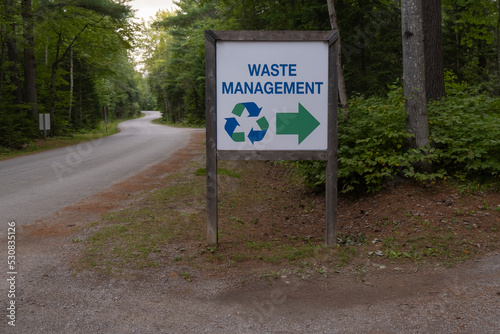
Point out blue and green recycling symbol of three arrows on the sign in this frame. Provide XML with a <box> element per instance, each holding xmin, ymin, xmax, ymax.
<box><xmin>224</xmin><ymin>102</ymin><xmax>269</xmax><ymax>145</ymax></box>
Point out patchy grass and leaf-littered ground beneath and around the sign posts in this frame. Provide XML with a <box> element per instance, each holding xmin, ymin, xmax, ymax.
<box><xmin>76</xmin><ymin>157</ymin><xmax>500</xmax><ymax>281</ymax></box>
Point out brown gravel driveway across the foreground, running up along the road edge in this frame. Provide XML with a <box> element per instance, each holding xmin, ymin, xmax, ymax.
<box><xmin>0</xmin><ymin>132</ymin><xmax>500</xmax><ymax>334</ymax></box>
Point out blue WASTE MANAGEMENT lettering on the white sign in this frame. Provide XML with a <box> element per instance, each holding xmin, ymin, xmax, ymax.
<box><xmin>222</xmin><ymin>64</ymin><xmax>324</xmax><ymax>95</ymax></box>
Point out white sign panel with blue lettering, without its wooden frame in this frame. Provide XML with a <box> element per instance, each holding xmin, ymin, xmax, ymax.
<box><xmin>216</xmin><ymin>41</ymin><xmax>328</xmax><ymax>150</ymax></box>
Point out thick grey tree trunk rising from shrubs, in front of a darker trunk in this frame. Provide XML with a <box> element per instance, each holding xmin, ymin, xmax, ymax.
<box><xmin>401</xmin><ymin>0</ymin><xmax>429</xmax><ymax>148</ymax></box>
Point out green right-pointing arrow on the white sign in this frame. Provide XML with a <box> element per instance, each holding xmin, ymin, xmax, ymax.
<box><xmin>276</xmin><ymin>103</ymin><xmax>320</xmax><ymax>145</ymax></box>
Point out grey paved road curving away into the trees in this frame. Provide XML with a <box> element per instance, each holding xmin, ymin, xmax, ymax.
<box><xmin>0</xmin><ymin>111</ymin><xmax>192</xmax><ymax>239</ymax></box>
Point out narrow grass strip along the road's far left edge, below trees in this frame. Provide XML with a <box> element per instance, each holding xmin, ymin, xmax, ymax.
<box><xmin>0</xmin><ymin>119</ymin><xmax>130</xmax><ymax>160</ymax></box>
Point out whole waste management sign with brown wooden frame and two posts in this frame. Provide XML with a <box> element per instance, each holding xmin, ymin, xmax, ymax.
<box><xmin>205</xmin><ymin>30</ymin><xmax>338</xmax><ymax>245</ymax></box>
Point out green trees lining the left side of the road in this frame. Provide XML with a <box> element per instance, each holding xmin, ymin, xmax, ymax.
<box><xmin>0</xmin><ymin>0</ymin><xmax>142</xmax><ymax>149</ymax></box>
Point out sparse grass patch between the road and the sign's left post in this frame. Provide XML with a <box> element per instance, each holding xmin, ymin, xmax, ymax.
<box><xmin>77</xmin><ymin>166</ymin><xmax>204</xmax><ymax>275</ymax></box>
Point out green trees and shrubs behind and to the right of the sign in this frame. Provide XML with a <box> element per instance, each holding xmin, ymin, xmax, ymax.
<box><xmin>139</xmin><ymin>0</ymin><xmax>499</xmax><ymax>191</ymax></box>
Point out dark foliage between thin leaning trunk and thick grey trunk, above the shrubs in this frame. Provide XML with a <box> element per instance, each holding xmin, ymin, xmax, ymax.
<box><xmin>336</xmin><ymin>1</ymin><xmax>403</xmax><ymax>95</ymax></box>
